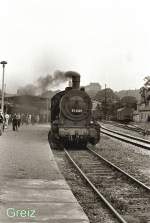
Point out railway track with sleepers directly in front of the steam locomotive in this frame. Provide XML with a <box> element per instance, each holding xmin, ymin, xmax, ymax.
<box><xmin>64</xmin><ymin>149</ymin><xmax>150</xmax><ymax>223</ymax></box>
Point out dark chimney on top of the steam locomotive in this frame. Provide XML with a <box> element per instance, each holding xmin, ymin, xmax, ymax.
<box><xmin>65</xmin><ymin>71</ymin><xmax>80</xmax><ymax>89</ymax></box>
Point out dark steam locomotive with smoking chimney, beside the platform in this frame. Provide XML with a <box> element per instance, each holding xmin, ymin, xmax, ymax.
<box><xmin>48</xmin><ymin>71</ymin><xmax>100</xmax><ymax>149</ymax></box>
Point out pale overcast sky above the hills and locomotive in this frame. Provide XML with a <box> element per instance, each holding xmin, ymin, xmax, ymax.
<box><xmin>0</xmin><ymin>0</ymin><xmax>150</xmax><ymax>92</ymax></box>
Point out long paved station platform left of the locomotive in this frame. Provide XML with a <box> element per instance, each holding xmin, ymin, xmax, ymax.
<box><xmin>0</xmin><ymin>125</ymin><xmax>89</xmax><ymax>223</ymax></box>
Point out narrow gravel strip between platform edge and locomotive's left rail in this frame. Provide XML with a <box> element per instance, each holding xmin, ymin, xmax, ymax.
<box><xmin>53</xmin><ymin>151</ymin><xmax>118</xmax><ymax>223</ymax></box>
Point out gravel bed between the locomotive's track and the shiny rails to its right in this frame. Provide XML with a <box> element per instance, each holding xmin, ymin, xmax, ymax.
<box><xmin>95</xmin><ymin>134</ymin><xmax>150</xmax><ymax>186</ymax></box>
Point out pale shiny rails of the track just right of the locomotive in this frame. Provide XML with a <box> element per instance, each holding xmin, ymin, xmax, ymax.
<box><xmin>101</xmin><ymin>126</ymin><xmax>150</xmax><ymax>150</ymax></box>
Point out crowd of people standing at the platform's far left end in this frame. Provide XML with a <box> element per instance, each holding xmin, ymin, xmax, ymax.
<box><xmin>0</xmin><ymin>110</ymin><xmax>40</xmax><ymax>135</ymax></box>
